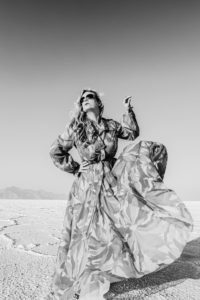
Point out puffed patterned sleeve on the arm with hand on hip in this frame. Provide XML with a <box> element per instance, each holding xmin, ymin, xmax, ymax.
<box><xmin>50</xmin><ymin>126</ymin><xmax>80</xmax><ymax>174</ymax></box>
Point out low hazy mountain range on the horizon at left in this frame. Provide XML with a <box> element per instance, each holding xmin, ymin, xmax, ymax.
<box><xmin>0</xmin><ymin>186</ymin><xmax>67</xmax><ymax>200</ymax></box>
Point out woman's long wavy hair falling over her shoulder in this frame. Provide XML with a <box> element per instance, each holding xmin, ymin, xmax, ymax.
<box><xmin>71</xmin><ymin>89</ymin><xmax>104</xmax><ymax>142</ymax></box>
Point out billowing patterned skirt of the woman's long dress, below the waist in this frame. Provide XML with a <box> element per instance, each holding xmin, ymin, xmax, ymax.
<box><xmin>48</xmin><ymin>111</ymin><xmax>192</xmax><ymax>300</ymax></box>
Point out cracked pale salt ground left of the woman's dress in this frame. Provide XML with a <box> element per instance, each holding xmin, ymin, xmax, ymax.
<box><xmin>0</xmin><ymin>199</ymin><xmax>66</xmax><ymax>300</ymax></box>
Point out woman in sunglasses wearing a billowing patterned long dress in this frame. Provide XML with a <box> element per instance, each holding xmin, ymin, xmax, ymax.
<box><xmin>50</xmin><ymin>90</ymin><xmax>192</xmax><ymax>300</ymax></box>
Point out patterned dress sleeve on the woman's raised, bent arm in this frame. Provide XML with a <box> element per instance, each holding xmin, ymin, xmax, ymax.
<box><xmin>116</xmin><ymin>106</ymin><xmax>139</xmax><ymax>140</ymax></box>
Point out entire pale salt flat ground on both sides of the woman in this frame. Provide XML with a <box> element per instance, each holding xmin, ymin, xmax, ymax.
<box><xmin>0</xmin><ymin>199</ymin><xmax>200</xmax><ymax>300</ymax></box>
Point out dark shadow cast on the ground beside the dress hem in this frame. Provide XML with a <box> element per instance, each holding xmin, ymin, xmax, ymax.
<box><xmin>107</xmin><ymin>238</ymin><xmax>200</xmax><ymax>300</ymax></box>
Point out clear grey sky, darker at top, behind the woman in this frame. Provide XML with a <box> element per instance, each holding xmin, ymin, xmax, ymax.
<box><xmin>0</xmin><ymin>0</ymin><xmax>200</xmax><ymax>200</ymax></box>
